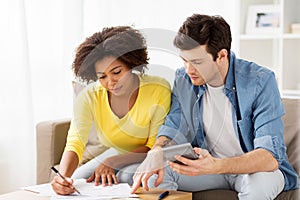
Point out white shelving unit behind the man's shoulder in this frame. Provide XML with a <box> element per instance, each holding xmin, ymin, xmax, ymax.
<box><xmin>238</xmin><ymin>0</ymin><xmax>300</xmax><ymax>94</ymax></box>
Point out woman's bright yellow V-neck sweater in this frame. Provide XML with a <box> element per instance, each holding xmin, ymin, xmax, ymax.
<box><xmin>65</xmin><ymin>75</ymin><xmax>171</xmax><ymax>160</ymax></box>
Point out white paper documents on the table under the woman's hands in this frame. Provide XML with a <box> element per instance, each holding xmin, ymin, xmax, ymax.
<box><xmin>22</xmin><ymin>179</ymin><xmax>138</xmax><ymax>200</ymax></box>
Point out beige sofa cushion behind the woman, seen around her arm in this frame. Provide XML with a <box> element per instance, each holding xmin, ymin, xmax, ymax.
<box><xmin>72</xmin><ymin>81</ymin><xmax>108</xmax><ymax>165</ymax></box>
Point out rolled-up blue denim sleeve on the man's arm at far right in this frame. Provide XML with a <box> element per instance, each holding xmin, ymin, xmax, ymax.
<box><xmin>252</xmin><ymin>74</ymin><xmax>286</xmax><ymax>164</ymax></box>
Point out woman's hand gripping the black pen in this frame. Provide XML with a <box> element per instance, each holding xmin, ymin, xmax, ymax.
<box><xmin>51</xmin><ymin>176</ymin><xmax>75</xmax><ymax>195</ymax></box>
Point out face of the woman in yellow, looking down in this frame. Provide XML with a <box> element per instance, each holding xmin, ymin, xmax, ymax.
<box><xmin>95</xmin><ymin>56</ymin><xmax>133</xmax><ymax>96</ymax></box>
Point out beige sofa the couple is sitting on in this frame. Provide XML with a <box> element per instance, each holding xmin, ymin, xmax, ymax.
<box><xmin>36</xmin><ymin>98</ymin><xmax>300</xmax><ymax>200</ymax></box>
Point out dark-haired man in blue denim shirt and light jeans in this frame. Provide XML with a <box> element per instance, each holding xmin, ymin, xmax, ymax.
<box><xmin>132</xmin><ymin>14</ymin><xmax>299</xmax><ymax>199</ymax></box>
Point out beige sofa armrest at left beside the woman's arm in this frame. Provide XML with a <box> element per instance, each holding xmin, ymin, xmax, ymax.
<box><xmin>36</xmin><ymin>119</ymin><xmax>70</xmax><ymax>184</ymax></box>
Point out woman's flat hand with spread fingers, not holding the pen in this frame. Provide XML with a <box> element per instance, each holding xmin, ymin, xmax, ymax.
<box><xmin>87</xmin><ymin>163</ymin><xmax>118</xmax><ymax>186</ymax></box>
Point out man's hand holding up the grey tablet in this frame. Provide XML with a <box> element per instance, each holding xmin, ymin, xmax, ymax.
<box><xmin>168</xmin><ymin>148</ymin><xmax>219</xmax><ymax>176</ymax></box>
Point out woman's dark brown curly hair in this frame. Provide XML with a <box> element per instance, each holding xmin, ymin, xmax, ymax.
<box><xmin>72</xmin><ymin>26</ymin><xmax>149</xmax><ymax>82</ymax></box>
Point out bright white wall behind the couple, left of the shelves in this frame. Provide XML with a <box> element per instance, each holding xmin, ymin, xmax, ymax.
<box><xmin>0</xmin><ymin>0</ymin><xmax>239</xmax><ymax>194</ymax></box>
